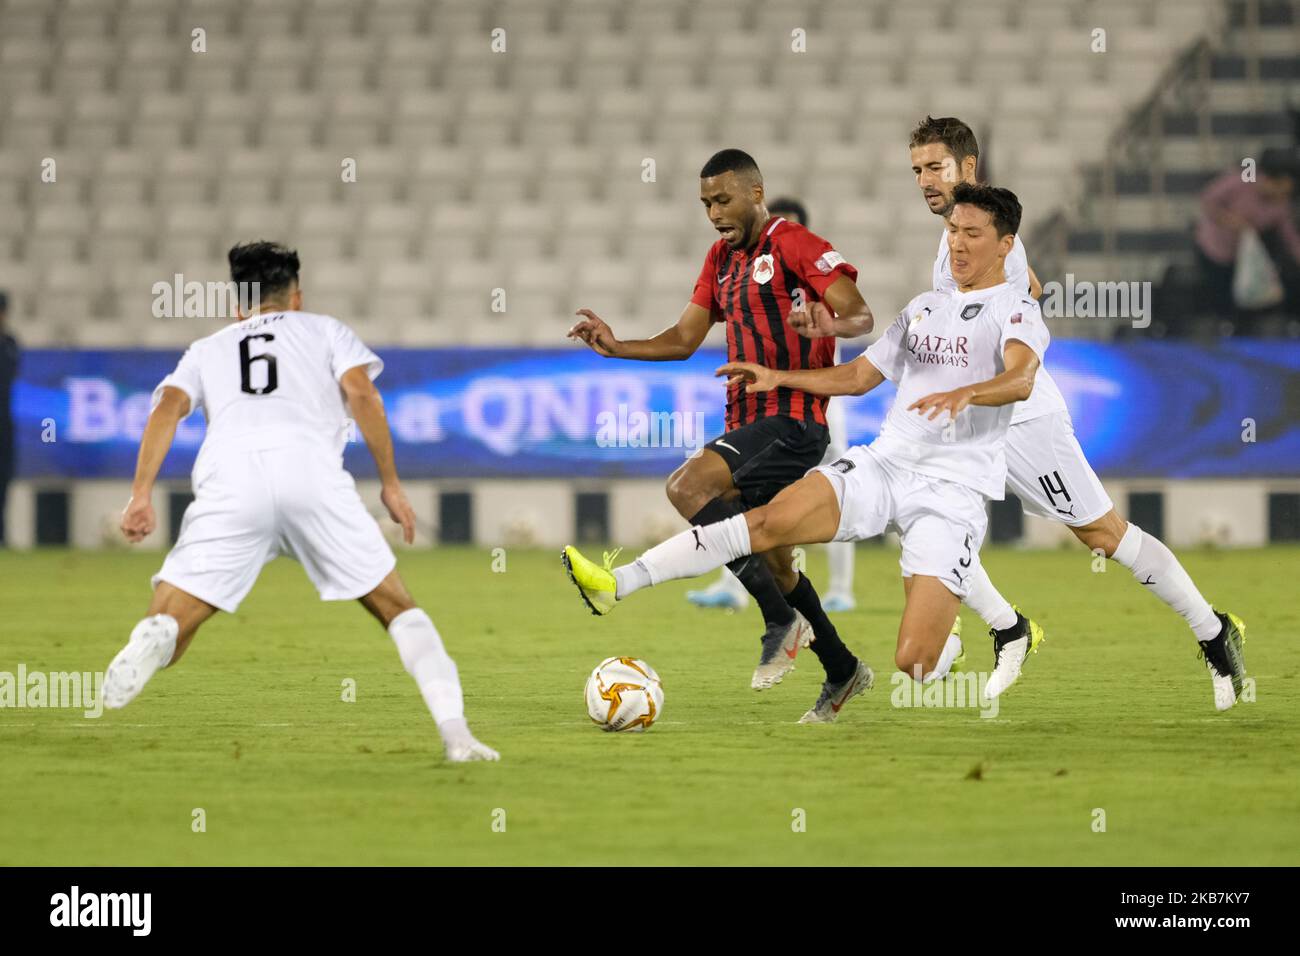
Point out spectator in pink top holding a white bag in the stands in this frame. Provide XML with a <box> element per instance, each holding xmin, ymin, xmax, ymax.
<box><xmin>1196</xmin><ymin>150</ymin><xmax>1300</xmax><ymax>316</ymax></box>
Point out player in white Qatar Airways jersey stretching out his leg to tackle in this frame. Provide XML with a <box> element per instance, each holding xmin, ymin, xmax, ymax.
<box><xmin>563</xmin><ymin>185</ymin><xmax>1048</xmax><ymax>723</ymax></box>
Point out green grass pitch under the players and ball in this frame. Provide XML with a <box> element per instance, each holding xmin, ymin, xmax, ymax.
<box><xmin>0</xmin><ymin>546</ymin><xmax>1300</xmax><ymax>865</ymax></box>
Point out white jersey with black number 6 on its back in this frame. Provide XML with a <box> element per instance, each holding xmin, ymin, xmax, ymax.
<box><xmin>153</xmin><ymin>312</ymin><xmax>384</xmax><ymax>468</ymax></box>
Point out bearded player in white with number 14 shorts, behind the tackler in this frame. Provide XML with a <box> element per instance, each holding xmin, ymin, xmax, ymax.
<box><xmin>910</xmin><ymin>116</ymin><xmax>1245</xmax><ymax>710</ymax></box>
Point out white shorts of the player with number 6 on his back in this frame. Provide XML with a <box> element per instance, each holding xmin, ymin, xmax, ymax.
<box><xmin>153</xmin><ymin>446</ymin><xmax>397</xmax><ymax>611</ymax></box>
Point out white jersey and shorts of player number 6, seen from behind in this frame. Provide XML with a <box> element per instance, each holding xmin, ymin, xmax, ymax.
<box><xmin>153</xmin><ymin>312</ymin><xmax>397</xmax><ymax>611</ymax></box>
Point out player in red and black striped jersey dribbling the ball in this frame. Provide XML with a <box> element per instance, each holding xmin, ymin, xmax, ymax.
<box><xmin>569</xmin><ymin>150</ymin><xmax>872</xmax><ymax>691</ymax></box>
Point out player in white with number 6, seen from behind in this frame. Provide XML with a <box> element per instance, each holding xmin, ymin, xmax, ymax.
<box><xmin>104</xmin><ymin>242</ymin><xmax>498</xmax><ymax>762</ymax></box>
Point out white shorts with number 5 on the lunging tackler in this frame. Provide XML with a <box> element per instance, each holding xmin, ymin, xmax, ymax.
<box><xmin>813</xmin><ymin>445</ymin><xmax>988</xmax><ymax>598</ymax></box>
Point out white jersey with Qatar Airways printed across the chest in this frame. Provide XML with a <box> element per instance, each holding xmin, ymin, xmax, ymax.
<box><xmin>859</xmin><ymin>282</ymin><xmax>1050</xmax><ymax>499</ymax></box>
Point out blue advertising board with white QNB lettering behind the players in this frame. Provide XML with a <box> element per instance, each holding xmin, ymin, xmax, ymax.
<box><xmin>13</xmin><ymin>339</ymin><xmax>1300</xmax><ymax>479</ymax></box>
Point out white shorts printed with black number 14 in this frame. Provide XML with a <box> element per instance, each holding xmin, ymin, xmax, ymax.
<box><xmin>1006</xmin><ymin>412</ymin><xmax>1114</xmax><ymax>528</ymax></box>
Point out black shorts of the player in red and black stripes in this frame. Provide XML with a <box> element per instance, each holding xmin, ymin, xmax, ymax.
<box><xmin>705</xmin><ymin>415</ymin><xmax>831</xmax><ymax>507</ymax></box>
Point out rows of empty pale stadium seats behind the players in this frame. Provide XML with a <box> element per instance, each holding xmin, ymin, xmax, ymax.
<box><xmin>0</xmin><ymin>0</ymin><xmax>1242</xmax><ymax>342</ymax></box>
